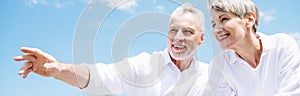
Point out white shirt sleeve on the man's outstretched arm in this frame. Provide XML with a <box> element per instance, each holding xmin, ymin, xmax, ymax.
<box><xmin>82</xmin><ymin>53</ymin><xmax>151</xmax><ymax>95</ymax></box>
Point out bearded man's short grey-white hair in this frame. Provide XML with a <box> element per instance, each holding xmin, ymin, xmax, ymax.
<box><xmin>170</xmin><ymin>3</ymin><xmax>205</xmax><ymax>32</ymax></box>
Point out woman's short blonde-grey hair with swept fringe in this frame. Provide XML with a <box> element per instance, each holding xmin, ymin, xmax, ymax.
<box><xmin>208</xmin><ymin>0</ymin><xmax>259</xmax><ymax>32</ymax></box>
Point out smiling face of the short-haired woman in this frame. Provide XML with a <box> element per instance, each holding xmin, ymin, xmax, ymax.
<box><xmin>211</xmin><ymin>10</ymin><xmax>247</xmax><ymax>50</ymax></box>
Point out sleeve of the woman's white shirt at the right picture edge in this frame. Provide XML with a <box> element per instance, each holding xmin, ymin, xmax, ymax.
<box><xmin>274</xmin><ymin>34</ymin><xmax>300</xmax><ymax>96</ymax></box>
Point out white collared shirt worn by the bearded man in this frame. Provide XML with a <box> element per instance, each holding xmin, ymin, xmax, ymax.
<box><xmin>82</xmin><ymin>49</ymin><xmax>208</xmax><ymax>96</ymax></box>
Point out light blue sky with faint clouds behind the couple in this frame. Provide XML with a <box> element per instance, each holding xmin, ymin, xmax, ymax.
<box><xmin>0</xmin><ymin>0</ymin><xmax>300</xmax><ymax>96</ymax></box>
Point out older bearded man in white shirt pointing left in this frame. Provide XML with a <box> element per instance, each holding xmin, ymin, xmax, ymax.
<box><xmin>14</xmin><ymin>4</ymin><xmax>208</xmax><ymax>96</ymax></box>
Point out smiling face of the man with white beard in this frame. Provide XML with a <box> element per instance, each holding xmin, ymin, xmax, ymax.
<box><xmin>168</xmin><ymin>13</ymin><xmax>204</xmax><ymax>60</ymax></box>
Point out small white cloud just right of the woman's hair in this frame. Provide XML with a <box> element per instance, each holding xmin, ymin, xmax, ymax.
<box><xmin>259</xmin><ymin>9</ymin><xmax>277</xmax><ymax>24</ymax></box>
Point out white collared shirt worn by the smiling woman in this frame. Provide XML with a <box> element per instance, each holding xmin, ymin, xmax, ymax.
<box><xmin>206</xmin><ymin>33</ymin><xmax>300</xmax><ymax>96</ymax></box>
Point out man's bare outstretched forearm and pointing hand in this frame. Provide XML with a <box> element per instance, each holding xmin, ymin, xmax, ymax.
<box><xmin>14</xmin><ymin>47</ymin><xmax>89</xmax><ymax>88</ymax></box>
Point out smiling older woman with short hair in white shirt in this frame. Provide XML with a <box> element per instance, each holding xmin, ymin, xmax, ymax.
<box><xmin>203</xmin><ymin>0</ymin><xmax>300</xmax><ymax>96</ymax></box>
